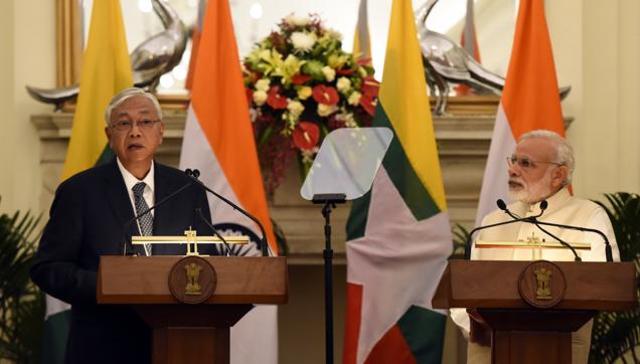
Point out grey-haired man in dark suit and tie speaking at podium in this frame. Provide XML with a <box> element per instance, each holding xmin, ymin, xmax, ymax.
<box><xmin>31</xmin><ymin>88</ymin><xmax>211</xmax><ymax>363</ymax></box>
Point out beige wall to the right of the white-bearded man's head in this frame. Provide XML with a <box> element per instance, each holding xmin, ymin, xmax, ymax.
<box><xmin>547</xmin><ymin>0</ymin><xmax>640</xmax><ymax>199</ymax></box>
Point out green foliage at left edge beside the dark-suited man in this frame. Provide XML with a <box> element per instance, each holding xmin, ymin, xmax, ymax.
<box><xmin>0</xmin><ymin>206</ymin><xmax>45</xmax><ymax>363</ymax></box>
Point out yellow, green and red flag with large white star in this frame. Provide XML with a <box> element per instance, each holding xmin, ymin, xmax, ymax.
<box><xmin>343</xmin><ymin>0</ymin><xmax>452</xmax><ymax>364</ymax></box>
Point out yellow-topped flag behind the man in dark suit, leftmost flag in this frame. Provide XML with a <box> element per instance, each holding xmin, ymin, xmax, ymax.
<box><xmin>42</xmin><ymin>0</ymin><xmax>133</xmax><ymax>363</ymax></box>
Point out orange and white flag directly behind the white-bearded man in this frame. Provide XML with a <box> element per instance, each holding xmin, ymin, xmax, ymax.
<box><xmin>451</xmin><ymin>0</ymin><xmax>564</xmax><ymax>332</ymax></box>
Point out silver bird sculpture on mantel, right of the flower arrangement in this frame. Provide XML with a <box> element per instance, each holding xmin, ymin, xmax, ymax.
<box><xmin>416</xmin><ymin>0</ymin><xmax>571</xmax><ymax>115</ymax></box>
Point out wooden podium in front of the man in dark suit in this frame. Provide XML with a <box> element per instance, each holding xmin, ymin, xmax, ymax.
<box><xmin>97</xmin><ymin>256</ymin><xmax>288</xmax><ymax>364</ymax></box>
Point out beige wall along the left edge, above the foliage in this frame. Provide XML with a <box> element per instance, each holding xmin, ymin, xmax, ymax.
<box><xmin>0</xmin><ymin>0</ymin><xmax>55</xmax><ymax>215</ymax></box>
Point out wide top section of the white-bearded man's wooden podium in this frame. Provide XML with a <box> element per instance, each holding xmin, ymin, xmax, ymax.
<box><xmin>432</xmin><ymin>260</ymin><xmax>638</xmax><ymax>311</ymax></box>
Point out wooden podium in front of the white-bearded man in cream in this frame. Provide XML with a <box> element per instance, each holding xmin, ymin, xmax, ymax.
<box><xmin>432</xmin><ymin>260</ymin><xmax>637</xmax><ymax>364</ymax></box>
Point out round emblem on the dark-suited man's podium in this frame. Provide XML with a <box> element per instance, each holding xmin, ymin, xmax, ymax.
<box><xmin>168</xmin><ymin>256</ymin><xmax>217</xmax><ymax>304</ymax></box>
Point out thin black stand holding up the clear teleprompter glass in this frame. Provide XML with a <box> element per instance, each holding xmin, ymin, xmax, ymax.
<box><xmin>312</xmin><ymin>193</ymin><xmax>347</xmax><ymax>364</ymax></box>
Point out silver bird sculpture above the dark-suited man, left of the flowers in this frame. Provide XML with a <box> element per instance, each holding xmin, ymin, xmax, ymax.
<box><xmin>26</xmin><ymin>0</ymin><xmax>188</xmax><ymax>111</ymax></box>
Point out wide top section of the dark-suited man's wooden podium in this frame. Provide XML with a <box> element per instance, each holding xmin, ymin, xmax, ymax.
<box><xmin>97</xmin><ymin>255</ymin><xmax>288</xmax><ymax>304</ymax></box>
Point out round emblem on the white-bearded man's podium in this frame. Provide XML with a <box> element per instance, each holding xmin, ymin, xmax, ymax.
<box><xmin>518</xmin><ymin>260</ymin><xmax>567</xmax><ymax>308</ymax></box>
